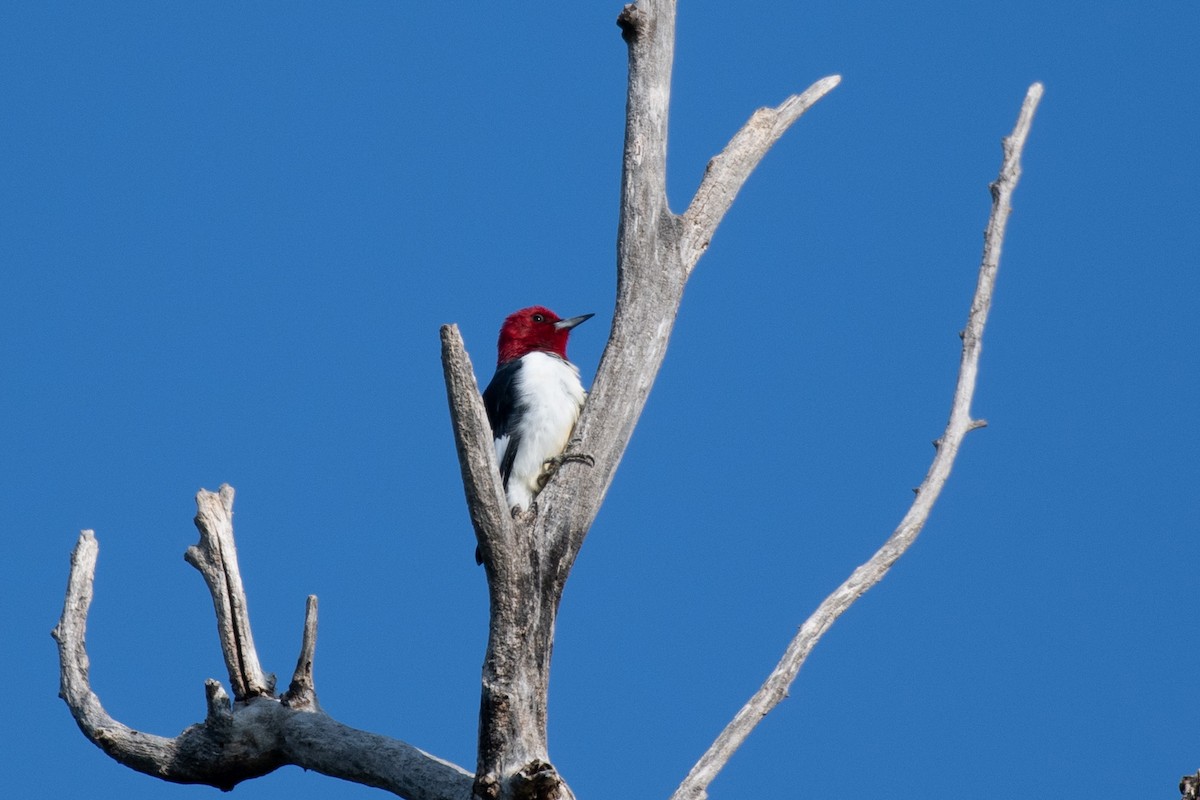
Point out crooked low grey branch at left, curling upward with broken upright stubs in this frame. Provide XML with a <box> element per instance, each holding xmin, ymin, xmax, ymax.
<box><xmin>53</xmin><ymin>496</ymin><xmax>472</xmax><ymax>800</ymax></box>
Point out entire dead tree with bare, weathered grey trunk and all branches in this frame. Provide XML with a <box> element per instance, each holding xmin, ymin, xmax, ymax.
<box><xmin>54</xmin><ymin>0</ymin><xmax>1042</xmax><ymax>800</ymax></box>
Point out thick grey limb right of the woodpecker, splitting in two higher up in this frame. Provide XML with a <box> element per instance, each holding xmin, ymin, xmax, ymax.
<box><xmin>536</xmin><ymin>0</ymin><xmax>840</xmax><ymax>566</ymax></box>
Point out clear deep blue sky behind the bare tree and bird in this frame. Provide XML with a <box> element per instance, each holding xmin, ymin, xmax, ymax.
<box><xmin>0</xmin><ymin>0</ymin><xmax>1200</xmax><ymax>800</ymax></box>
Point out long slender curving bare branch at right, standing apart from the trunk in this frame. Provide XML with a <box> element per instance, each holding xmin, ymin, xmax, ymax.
<box><xmin>671</xmin><ymin>84</ymin><xmax>1042</xmax><ymax>800</ymax></box>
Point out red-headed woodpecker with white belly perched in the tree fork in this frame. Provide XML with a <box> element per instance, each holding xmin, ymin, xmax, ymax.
<box><xmin>484</xmin><ymin>306</ymin><xmax>592</xmax><ymax>511</ymax></box>
